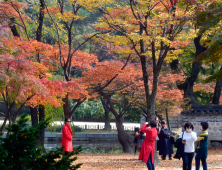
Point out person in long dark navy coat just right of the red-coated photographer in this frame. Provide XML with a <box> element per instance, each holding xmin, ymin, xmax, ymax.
<box><xmin>159</xmin><ymin>120</ymin><xmax>174</xmax><ymax>160</ymax></box>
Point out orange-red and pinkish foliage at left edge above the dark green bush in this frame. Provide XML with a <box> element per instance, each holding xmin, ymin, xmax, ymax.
<box><xmin>0</xmin><ymin>37</ymin><xmax>90</xmax><ymax>107</ymax></box>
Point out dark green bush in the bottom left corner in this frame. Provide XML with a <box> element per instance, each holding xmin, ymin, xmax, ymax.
<box><xmin>0</xmin><ymin>114</ymin><xmax>82</xmax><ymax>170</ymax></box>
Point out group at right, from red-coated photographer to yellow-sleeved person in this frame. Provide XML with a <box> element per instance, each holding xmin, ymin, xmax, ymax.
<box><xmin>139</xmin><ymin>117</ymin><xmax>208</xmax><ymax>170</ymax></box>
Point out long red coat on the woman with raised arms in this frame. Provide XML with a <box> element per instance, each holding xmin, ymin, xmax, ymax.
<box><xmin>139</xmin><ymin>123</ymin><xmax>157</xmax><ymax>163</ymax></box>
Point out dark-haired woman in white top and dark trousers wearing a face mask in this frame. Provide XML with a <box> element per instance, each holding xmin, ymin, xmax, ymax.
<box><xmin>180</xmin><ymin>122</ymin><xmax>197</xmax><ymax>170</ymax></box>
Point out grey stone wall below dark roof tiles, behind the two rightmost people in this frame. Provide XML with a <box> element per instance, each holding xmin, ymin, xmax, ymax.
<box><xmin>182</xmin><ymin>115</ymin><xmax>222</xmax><ymax>143</ymax></box>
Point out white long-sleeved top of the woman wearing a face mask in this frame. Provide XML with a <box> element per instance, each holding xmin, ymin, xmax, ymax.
<box><xmin>180</xmin><ymin>131</ymin><xmax>197</xmax><ymax>153</ymax></box>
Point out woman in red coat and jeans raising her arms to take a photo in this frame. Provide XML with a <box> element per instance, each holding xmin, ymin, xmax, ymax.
<box><xmin>139</xmin><ymin>120</ymin><xmax>157</xmax><ymax>170</ymax></box>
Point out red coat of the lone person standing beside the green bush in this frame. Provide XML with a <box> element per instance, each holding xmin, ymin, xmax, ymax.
<box><xmin>62</xmin><ymin>124</ymin><xmax>73</xmax><ymax>152</ymax></box>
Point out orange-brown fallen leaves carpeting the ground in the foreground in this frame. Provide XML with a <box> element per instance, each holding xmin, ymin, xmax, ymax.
<box><xmin>75</xmin><ymin>149</ymin><xmax>222</xmax><ymax>170</ymax></box>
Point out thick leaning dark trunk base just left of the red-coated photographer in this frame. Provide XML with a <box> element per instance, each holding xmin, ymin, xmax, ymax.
<box><xmin>116</xmin><ymin>117</ymin><xmax>134</xmax><ymax>153</ymax></box>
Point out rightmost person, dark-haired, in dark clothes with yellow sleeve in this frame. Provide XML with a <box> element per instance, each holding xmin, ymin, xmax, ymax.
<box><xmin>195</xmin><ymin>122</ymin><xmax>208</xmax><ymax>170</ymax></box>
